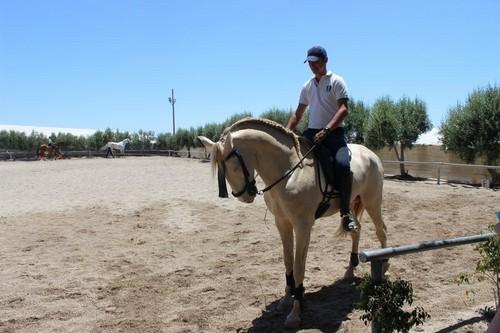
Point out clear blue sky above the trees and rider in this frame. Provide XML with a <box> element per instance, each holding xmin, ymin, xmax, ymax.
<box><xmin>0</xmin><ymin>0</ymin><xmax>500</xmax><ymax>133</ymax></box>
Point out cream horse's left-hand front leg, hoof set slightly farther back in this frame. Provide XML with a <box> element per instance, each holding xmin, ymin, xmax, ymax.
<box><xmin>274</xmin><ymin>217</ymin><xmax>295</xmax><ymax>311</ymax></box>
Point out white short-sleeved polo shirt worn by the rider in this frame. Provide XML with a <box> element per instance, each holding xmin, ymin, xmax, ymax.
<box><xmin>299</xmin><ymin>71</ymin><xmax>349</xmax><ymax>129</ymax></box>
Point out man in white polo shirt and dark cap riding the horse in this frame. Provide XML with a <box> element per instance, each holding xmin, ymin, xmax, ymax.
<box><xmin>287</xmin><ymin>46</ymin><xmax>356</xmax><ymax>231</ymax></box>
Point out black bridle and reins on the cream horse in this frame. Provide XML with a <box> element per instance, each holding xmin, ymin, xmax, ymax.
<box><xmin>218</xmin><ymin>144</ymin><xmax>317</xmax><ymax>198</ymax></box>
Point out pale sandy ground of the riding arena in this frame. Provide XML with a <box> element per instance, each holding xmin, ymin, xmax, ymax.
<box><xmin>0</xmin><ymin>157</ymin><xmax>500</xmax><ymax>333</ymax></box>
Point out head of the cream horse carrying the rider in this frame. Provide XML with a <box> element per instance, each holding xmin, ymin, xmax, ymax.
<box><xmin>198</xmin><ymin>132</ymin><xmax>257</xmax><ymax>203</ymax></box>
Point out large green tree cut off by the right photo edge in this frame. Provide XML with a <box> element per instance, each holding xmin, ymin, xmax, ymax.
<box><xmin>440</xmin><ymin>86</ymin><xmax>500</xmax><ymax>186</ymax></box>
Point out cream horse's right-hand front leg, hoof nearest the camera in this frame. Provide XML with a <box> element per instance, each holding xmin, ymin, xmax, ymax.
<box><xmin>285</xmin><ymin>219</ymin><xmax>314</xmax><ymax>328</ymax></box>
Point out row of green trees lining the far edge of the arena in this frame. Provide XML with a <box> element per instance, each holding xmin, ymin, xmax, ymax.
<box><xmin>0</xmin><ymin>85</ymin><xmax>500</xmax><ymax>180</ymax></box>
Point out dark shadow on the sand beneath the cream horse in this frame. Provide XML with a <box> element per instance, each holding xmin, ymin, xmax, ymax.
<box><xmin>247</xmin><ymin>278</ymin><xmax>360</xmax><ymax>333</ymax></box>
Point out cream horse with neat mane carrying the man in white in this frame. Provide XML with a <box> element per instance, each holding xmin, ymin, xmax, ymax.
<box><xmin>199</xmin><ymin>118</ymin><xmax>386</xmax><ymax>328</ymax></box>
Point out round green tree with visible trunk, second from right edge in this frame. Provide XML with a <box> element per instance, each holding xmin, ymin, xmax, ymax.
<box><xmin>365</xmin><ymin>97</ymin><xmax>432</xmax><ymax>176</ymax></box>
